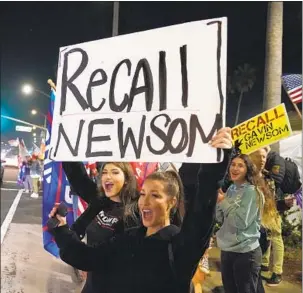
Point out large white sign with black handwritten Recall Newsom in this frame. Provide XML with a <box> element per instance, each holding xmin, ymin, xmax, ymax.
<box><xmin>51</xmin><ymin>18</ymin><xmax>227</xmax><ymax>162</ymax></box>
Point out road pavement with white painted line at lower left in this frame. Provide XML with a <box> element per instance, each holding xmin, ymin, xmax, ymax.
<box><xmin>1</xmin><ymin>168</ymin><xmax>81</xmax><ymax>293</ymax></box>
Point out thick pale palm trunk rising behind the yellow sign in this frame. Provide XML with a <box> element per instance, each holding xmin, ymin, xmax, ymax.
<box><xmin>263</xmin><ymin>2</ymin><xmax>283</xmax><ymax>152</ymax></box>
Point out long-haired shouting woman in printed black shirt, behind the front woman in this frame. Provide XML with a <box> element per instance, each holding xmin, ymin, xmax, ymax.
<box><xmin>63</xmin><ymin>162</ymin><xmax>139</xmax><ymax>293</ymax></box>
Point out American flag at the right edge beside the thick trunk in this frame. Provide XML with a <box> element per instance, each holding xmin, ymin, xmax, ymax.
<box><xmin>282</xmin><ymin>74</ymin><xmax>302</xmax><ymax>104</ymax></box>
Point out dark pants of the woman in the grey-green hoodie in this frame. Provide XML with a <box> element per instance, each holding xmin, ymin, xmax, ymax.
<box><xmin>221</xmin><ymin>247</ymin><xmax>262</xmax><ymax>293</ymax></box>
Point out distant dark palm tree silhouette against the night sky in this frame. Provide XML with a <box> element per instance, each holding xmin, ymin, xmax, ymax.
<box><xmin>232</xmin><ymin>63</ymin><xmax>256</xmax><ymax>125</ymax></box>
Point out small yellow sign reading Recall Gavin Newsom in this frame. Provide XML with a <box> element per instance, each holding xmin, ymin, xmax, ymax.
<box><xmin>232</xmin><ymin>104</ymin><xmax>292</xmax><ymax>154</ymax></box>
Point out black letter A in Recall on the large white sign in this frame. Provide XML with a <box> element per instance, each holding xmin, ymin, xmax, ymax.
<box><xmin>127</xmin><ymin>59</ymin><xmax>154</xmax><ymax>112</ymax></box>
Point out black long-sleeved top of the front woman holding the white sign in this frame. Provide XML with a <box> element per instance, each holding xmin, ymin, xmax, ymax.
<box><xmin>54</xmin><ymin>156</ymin><xmax>227</xmax><ymax>293</ymax></box>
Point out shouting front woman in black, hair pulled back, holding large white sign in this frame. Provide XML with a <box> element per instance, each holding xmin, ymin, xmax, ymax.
<box><xmin>50</xmin><ymin>128</ymin><xmax>232</xmax><ymax>293</ymax></box>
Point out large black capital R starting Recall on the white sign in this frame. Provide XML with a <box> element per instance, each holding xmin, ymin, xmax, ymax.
<box><xmin>60</xmin><ymin>48</ymin><xmax>89</xmax><ymax>115</ymax></box>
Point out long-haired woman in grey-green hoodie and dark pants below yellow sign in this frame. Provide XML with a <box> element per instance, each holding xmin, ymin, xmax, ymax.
<box><xmin>217</xmin><ymin>155</ymin><xmax>264</xmax><ymax>293</ymax></box>
